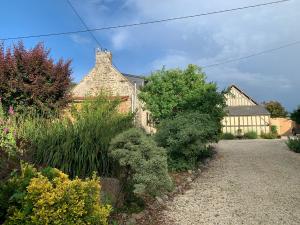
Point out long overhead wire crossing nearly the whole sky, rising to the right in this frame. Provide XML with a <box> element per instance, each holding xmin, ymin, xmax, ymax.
<box><xmin>0</xmin><ymin>0</ymin><xmax>291</xmax><ymax>41</ymax></box>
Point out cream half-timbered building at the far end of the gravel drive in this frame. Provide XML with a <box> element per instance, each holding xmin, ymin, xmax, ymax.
<box><xmin>222</xmin><ymin>85</ymin><xmax>270</xmax><ymax>135</ymax></box>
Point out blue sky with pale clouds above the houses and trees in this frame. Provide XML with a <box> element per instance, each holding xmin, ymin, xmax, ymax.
<box><xmin>0</xmin><ymin>0</ymin><xmax>300</xmax><ymax>111</ymax></box>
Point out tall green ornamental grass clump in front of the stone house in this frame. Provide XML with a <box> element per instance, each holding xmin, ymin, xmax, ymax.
<box><xmin>22</xmin><ymin>95</ymin><xmax>133</xmax><ymax>177</ymax></box>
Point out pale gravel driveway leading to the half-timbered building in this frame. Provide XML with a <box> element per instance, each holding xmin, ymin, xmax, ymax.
<box><xmin>163</xmin><ymin>140</ymin><xmax>300</xmax><ymax>225</ymax></box>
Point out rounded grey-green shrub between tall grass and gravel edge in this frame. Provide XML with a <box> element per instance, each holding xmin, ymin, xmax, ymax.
<box><xmin>109</xmin><ymin>128</ymin><xmax>172</xmax><ymax>196</ymax></box>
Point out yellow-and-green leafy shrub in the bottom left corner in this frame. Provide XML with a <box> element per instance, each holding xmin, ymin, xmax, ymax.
<box><xmin>0</xmin><ymin>164</ymin><xmax>111</xmax><ymax>225</ymax></box>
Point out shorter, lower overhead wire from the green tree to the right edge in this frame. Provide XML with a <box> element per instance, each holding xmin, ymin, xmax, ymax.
<box><xmin>202</xmin><ymin>41</ymin><xmax>300</xmax><ymax>69</ymax></box>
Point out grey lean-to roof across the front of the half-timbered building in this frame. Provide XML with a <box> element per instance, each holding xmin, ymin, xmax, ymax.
<box><xmin>226</xmin><ymin>105</ymin><xmax>270</xmax><ymax>116</ymax></box>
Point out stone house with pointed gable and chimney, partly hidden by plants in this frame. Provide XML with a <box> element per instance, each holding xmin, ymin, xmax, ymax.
<box><xmin>71</xmin><ymin>50</ymin><xmax>154</xmax><ymax>133</ymax></box>
